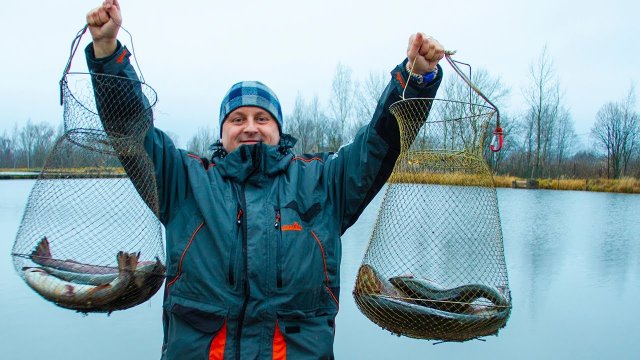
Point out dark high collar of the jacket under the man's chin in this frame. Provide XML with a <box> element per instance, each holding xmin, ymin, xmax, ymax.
<box><xmin>212</xmin><ymin>134</ymin><xmax>297</xmax><ymax>183</ymax></box>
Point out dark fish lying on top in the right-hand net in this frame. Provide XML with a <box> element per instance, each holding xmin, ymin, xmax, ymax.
<box><xmin>389</xmin><ymin>275</ymin><xmax>509</xmax><ymax>314</ymax></box>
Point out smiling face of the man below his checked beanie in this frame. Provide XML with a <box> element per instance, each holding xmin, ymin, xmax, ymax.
<box><xmin>222</xmin><ymin>106</ymin><xmax>280</xmax><ymax>153</ymax></box>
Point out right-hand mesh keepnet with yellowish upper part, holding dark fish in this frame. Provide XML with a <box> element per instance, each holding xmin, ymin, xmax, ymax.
<box><xmin>353</xmin><ymin>55</ymin><xmax>511</xmax><ymax>341</ymax></box>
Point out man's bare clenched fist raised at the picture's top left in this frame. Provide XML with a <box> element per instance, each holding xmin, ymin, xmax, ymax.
<box><xmin>87</xmin><ymin>0</ymin><xmax>122</xmax><ymax>58</ymax></box>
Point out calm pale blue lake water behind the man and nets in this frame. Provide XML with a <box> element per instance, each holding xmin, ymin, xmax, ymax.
<box><xmin>0</xmin><ymin>180</ymin><xmax>640</xmax><ymax>360</ymax></box>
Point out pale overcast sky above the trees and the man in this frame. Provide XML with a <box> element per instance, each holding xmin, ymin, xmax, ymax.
<box><xmin>0</xmin><ymin>0</ymin><xmax>640</xmax><ymax>144</ymax></box>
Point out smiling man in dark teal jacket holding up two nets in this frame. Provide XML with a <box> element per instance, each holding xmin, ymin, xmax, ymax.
<box><xmin>86</xmin><ymin>0</ymin><xmax>444</xmax><ymax>360</ymax></box>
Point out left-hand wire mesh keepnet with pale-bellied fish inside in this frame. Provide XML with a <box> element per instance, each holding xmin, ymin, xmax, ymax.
<box><xmin>12</xmin><ymin>29</ymin><xmax>165</xmax><ymax>313</ymax></box>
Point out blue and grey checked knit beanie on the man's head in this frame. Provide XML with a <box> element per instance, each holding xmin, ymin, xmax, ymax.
<box><xmin>220</xmin><ymin>81</ymin><xmax>282</xmax><ymax>137</ymax></box>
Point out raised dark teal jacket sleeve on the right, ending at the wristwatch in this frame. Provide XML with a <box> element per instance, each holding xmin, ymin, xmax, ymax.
<box><xmin>326</xmin><ymin>59</ymin><xmax>443</xmax><ymax>233</ymax></box>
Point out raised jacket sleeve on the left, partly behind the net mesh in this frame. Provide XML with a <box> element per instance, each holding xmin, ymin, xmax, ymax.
<box><xmin>85</xmin><ymin>42</ymin><xmax>187</xmax><ymax>225</ymax></box>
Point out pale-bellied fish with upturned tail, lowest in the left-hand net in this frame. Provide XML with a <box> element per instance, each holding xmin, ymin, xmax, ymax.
<box><xmin>23</xmin><ymin>251</ymin><xmax>139</xmax><ymax>312</ymax></box>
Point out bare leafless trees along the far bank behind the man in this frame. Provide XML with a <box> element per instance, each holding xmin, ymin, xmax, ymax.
<box><xmin>5</xmin><ymin>48</ymin><xmax>640</xmax><ymax>179</ymax></box>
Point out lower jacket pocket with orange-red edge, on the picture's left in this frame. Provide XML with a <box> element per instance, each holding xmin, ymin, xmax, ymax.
<box><xmin>163</xmin><ymin>304</ymin><xmax>226</xmax><ymax>360</ymax></box>
